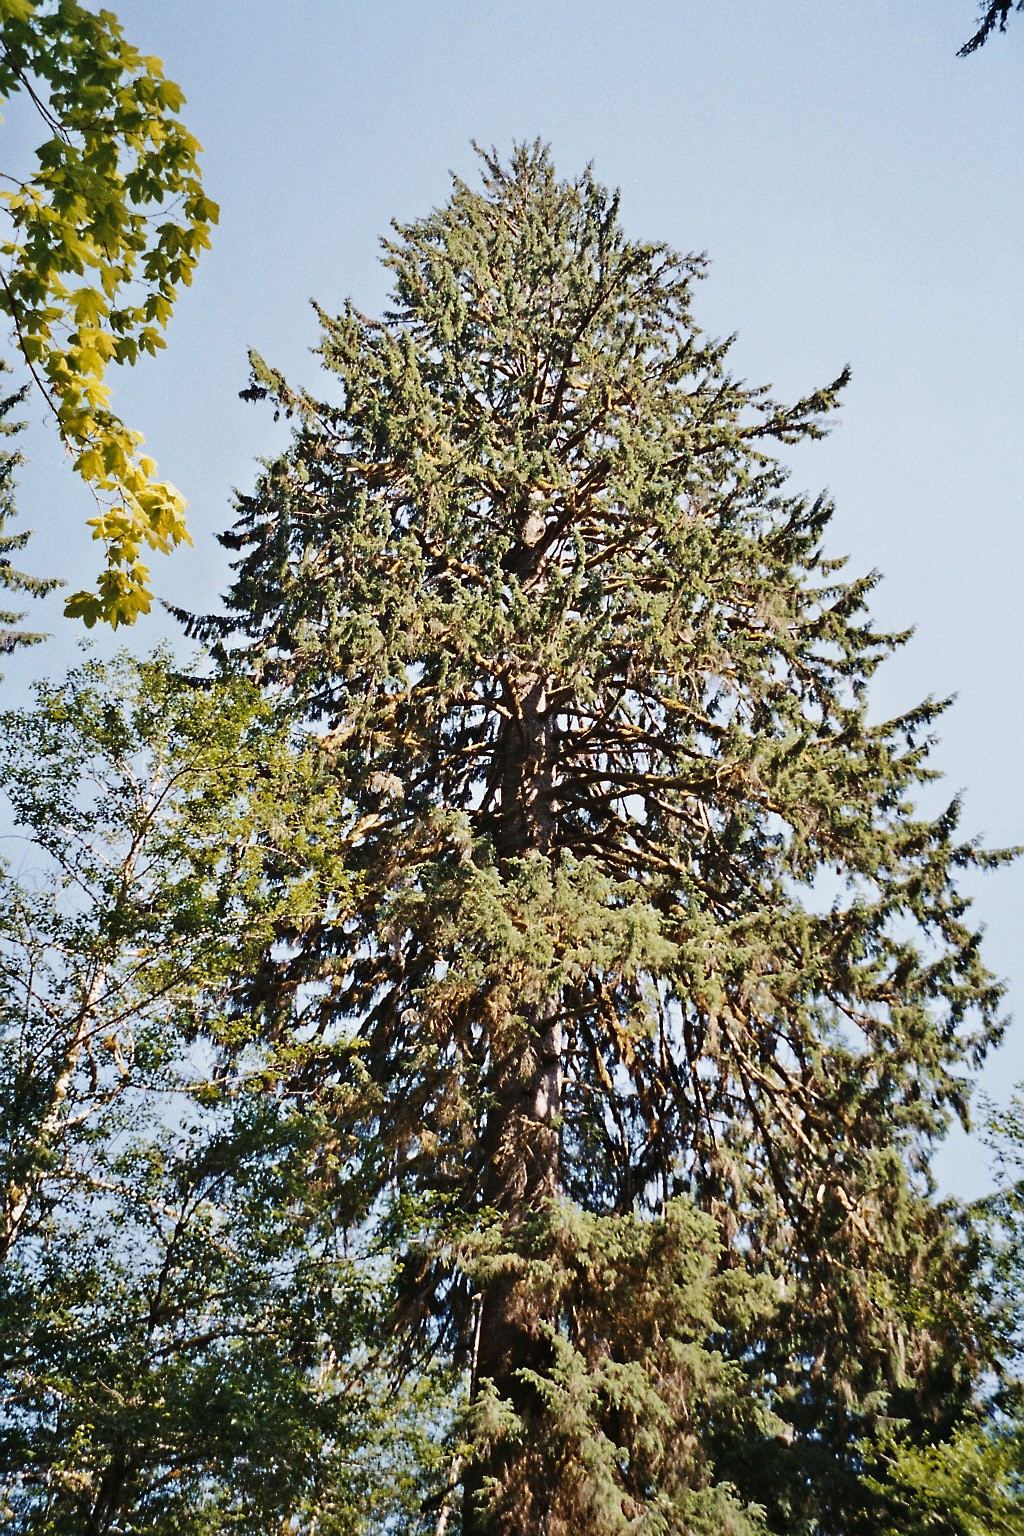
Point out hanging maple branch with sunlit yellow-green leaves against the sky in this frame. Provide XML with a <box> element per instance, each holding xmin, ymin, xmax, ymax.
<box><xmin>0</xmin><ymin>0</ymin><xmax>216</xmax><ymax>625</ymax></box>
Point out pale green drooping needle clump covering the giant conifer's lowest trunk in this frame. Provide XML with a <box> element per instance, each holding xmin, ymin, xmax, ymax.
<box><xmin>464</xmin><ymin>1200</ymin><xmax>783</xmax><ymax>1536</ymax></box>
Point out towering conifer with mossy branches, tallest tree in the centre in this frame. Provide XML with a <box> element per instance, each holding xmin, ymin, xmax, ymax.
<box><xmin>198</xmin><ymin>146</ymin><xmax>999</xmax><ymax>1536</ymax></box>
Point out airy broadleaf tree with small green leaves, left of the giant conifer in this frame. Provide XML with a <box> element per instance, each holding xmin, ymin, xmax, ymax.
<box><xmin>0</xmin><ymin>659</ymin><xmax>451</xmax><ymax>1536</ymax></box>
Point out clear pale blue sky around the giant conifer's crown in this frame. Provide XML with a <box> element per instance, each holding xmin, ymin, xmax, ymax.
<box><xmin>2</xmin><ymin>0</ymin><xmax>1024</xmax><ymax>1193</ymax></box>
